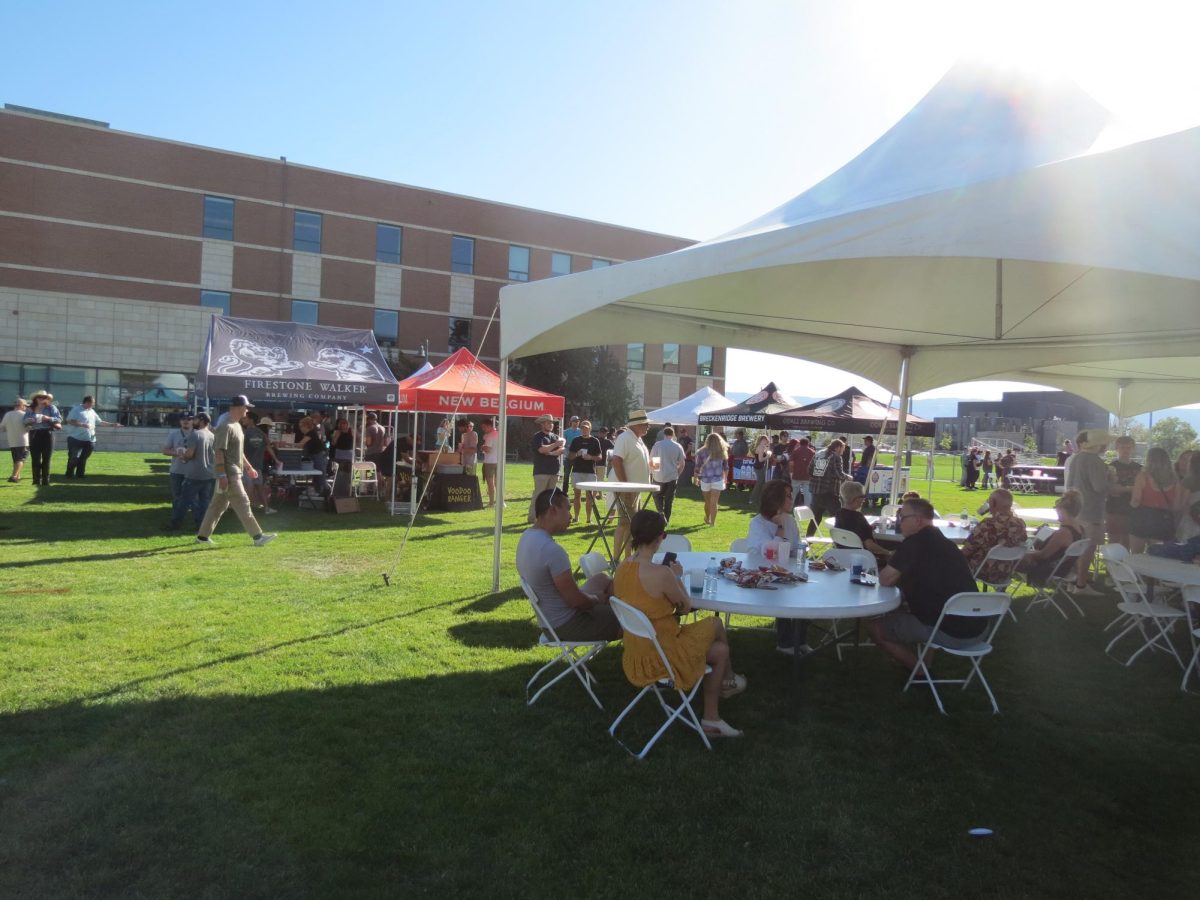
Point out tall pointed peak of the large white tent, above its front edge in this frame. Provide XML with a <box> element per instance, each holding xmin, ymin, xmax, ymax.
<box><xmin>710</xmin><ymin>61</ymin><xmax>1114</xmax><ymax>244</ymax></box>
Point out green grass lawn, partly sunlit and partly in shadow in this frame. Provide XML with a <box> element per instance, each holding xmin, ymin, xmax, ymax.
<box><xmin>0</xmin><ymin>451</ymin><xmax>1200</xmax><ymax>898</ymax></box>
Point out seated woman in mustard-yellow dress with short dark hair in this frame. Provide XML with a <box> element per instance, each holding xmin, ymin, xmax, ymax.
<box><xmin>613</xmin><ymin>510</ymin><xmax>746</xmax><ymax>738</ymax></box>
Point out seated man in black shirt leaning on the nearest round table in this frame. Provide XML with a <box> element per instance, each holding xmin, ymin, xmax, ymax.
<box><xmin>866</xmin><ymin>500</ymin><xmax>989</xmax><ymax>668</ymax></box>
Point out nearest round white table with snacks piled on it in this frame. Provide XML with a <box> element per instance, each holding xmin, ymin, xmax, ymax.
<box><xmin>655</xmin><ymin>551</ymin><xmax>900</xmax><ymax>662</ymax></box>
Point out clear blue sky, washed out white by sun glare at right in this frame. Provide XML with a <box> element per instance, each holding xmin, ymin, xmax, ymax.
<box><xmin>0</xmin><ymin>0</ymin><xmax>1200</xmax><ymax>405</ymax></box>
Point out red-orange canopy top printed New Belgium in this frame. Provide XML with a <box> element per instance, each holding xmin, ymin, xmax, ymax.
<box><xmin>373</xmin><ymin>347</ymin><xmax>566</xmax><ymax>419</ymax></box>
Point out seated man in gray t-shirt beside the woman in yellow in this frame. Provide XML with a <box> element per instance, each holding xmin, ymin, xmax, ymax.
<box><xmin>517</xmin><ymin>487</ymin><xmax>622</xmax><ymax>641</ymax></box>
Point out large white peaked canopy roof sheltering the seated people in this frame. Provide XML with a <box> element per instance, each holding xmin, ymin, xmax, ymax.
<box><xmin>487</xmin><ymin>60</ymin><xmax>1200</xmax><ymax>588</ymax></box>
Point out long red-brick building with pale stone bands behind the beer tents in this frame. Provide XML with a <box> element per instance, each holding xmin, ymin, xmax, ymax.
<box><xmin>0</xmin><ymin>107</ymin><xmax>725</xmax><ymax>426</ymax></box>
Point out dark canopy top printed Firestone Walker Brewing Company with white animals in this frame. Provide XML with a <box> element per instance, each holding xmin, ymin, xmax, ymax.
<box><xmin>196</xmin><ymin>316</ymin><xmax>397</xmax><ymax>406</ymax></box>
